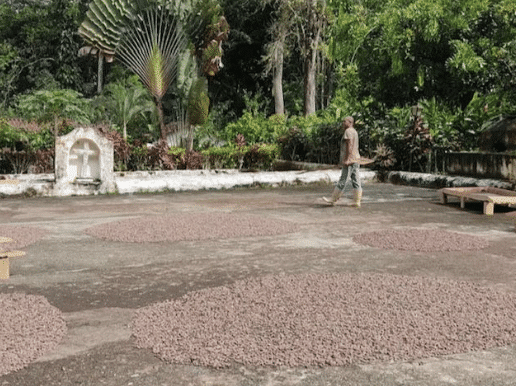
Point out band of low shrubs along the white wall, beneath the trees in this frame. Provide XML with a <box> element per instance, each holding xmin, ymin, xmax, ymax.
<box><xmin>0</xmin><ymin>85</ymin><xmax>516</xmax><ymax>173</ymax></box>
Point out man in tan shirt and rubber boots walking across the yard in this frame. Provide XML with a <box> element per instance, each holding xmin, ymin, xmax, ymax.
<box><xmin>323</xmin><ymin>117</ymin><xmax>362</xmax><ymax>207</ymax></box>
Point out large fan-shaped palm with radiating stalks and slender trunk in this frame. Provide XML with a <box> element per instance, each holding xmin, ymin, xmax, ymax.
<box><xmin>79</xmin><ymin>0</ymin><xmax>188</xmax><ymax>139</ymax></box>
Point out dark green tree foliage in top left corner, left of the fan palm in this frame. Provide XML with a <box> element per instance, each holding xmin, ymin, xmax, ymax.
<box><xmin>0</xmin><ymin>0</ymin><xmax>95</xmax><ymax>110</ymax></box>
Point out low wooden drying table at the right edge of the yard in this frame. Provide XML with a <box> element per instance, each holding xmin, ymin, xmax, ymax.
<box><xmin>440</xmin><ymin>187</ymin><xmax>516</xmax><ymax>215</ymax></box>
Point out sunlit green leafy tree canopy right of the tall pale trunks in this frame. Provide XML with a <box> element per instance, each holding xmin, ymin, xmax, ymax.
<box><xmin>330</xmin><ymin>0</ymin><xmax>516</xmax><ymax>106</ymax></box>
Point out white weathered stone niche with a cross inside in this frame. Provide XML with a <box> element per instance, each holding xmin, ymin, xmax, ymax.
<box><xmin>54</xmin><ymin>127</ymin><xmax>115</xmax><ymax>195</ymax></box>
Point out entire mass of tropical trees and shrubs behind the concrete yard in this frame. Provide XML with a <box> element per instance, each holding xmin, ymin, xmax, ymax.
<box><xmin>0</xmin><ymin>0</ymin><xmax>516</xmax><ymax>175</ymax></box>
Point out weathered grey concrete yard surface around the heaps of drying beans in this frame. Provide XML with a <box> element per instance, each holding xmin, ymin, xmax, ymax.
<box><xmin>0</xmin><ymin>182</ymin><xmax>516</xmax><ymax>386</ymax></box>
